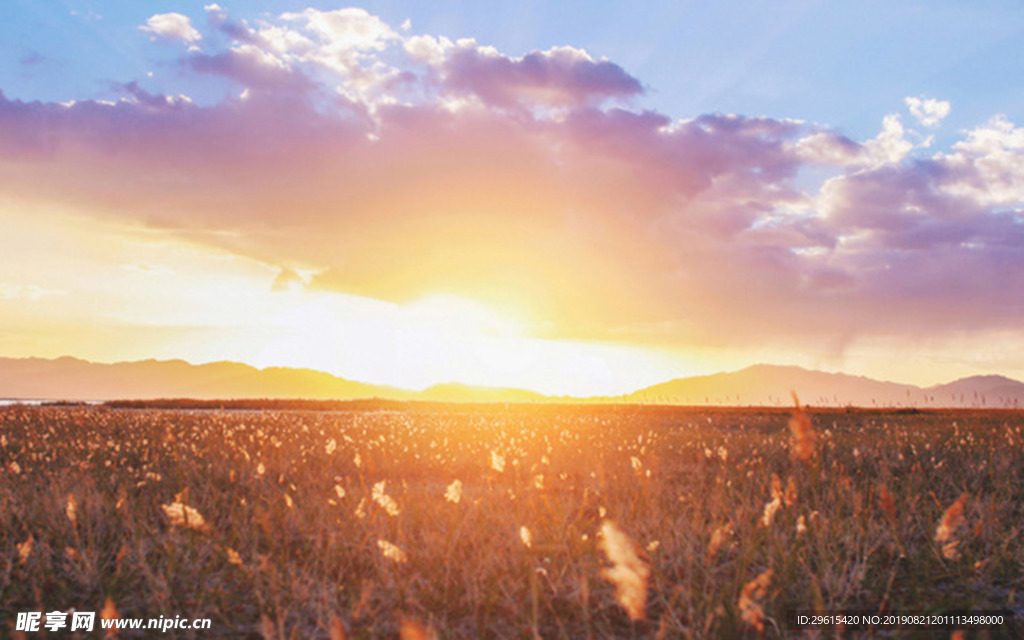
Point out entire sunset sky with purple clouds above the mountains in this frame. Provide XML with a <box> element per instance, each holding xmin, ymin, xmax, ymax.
<box><xmin>0</xmin><ymin>0</ymin><xmax>1024</xmax><ymax>395</ymax></box>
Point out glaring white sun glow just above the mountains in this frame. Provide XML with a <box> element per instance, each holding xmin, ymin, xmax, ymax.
<box><xmin>238</xmin><ymin>291</ymin><xmax>679</xmax><ymax>396</ymax></box>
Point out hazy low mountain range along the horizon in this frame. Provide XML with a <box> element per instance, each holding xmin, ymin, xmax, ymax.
<box><xmin>0</xmin><ymin>357</ymin><xmax>1024</xmax><ymax>408</ymax></box>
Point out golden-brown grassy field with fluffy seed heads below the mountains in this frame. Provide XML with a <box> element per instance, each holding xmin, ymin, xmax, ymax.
<box><xmin>0</xmin><ymin>404</ymin><xmax>1024</xmax><ymax>640</ymax></box>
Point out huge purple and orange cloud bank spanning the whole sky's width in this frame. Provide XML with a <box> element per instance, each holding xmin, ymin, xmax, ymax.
<box><xmin>0</xmin><ymin>7</ymin><xmax>1024</xmax><ymax>354</ymax></box>
